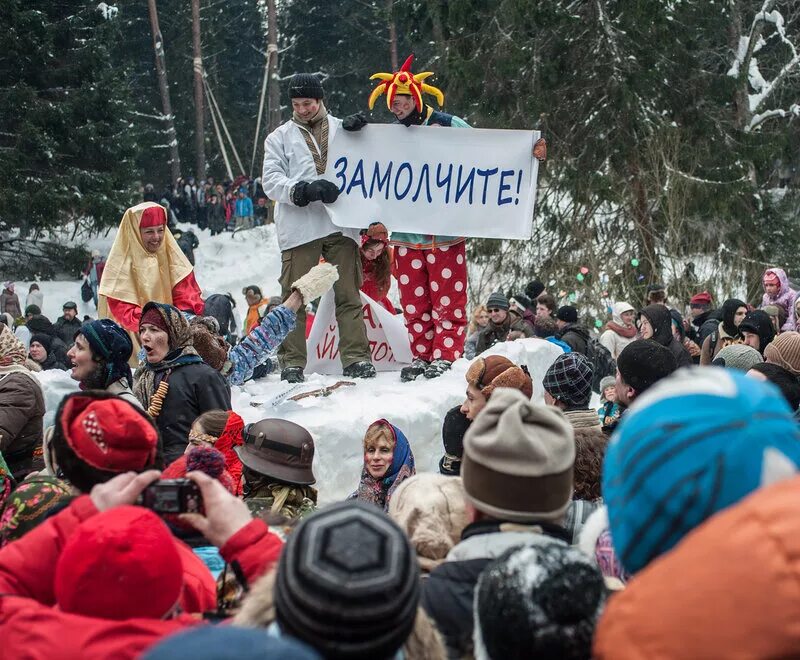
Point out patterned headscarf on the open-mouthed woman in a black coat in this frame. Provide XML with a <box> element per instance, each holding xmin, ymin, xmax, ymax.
<box><xmin>133</xmin><ymin>302</ymin><xmax>203</xmax><ymax>410</ymax></box>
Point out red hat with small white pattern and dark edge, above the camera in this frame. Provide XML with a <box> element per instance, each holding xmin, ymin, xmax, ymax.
<box><xmin>59</xmin><ymin>395</ymin><xmax>158</xmax><ymax>472</ymax></box>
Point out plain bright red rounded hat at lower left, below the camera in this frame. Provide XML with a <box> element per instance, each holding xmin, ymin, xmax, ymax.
<box><xmin>54</xmin><ymin>506</ymin><xmax>183</xmax><ymax>621</ymax></box>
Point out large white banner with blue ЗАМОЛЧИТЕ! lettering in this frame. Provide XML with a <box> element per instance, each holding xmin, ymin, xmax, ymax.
<box><xmin>325</xmin><ymin>124</ymin><xmax>540</xmax><ymax>239</ymax></box>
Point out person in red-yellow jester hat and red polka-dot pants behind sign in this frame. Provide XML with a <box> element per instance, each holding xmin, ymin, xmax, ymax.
<box><xmin>343</xmin><ymin>54</ymin><xmax>546</xmax><ymax>381</ymax></box>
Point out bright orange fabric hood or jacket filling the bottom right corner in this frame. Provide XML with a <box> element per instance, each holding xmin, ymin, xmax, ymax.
<box><xmin>594</xmin><ymin>477</ymin><xmax>800</xmax><ymax>660</ymax></box>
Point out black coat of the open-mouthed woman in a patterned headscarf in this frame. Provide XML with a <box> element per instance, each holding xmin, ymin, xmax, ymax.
<box><xmin>156</xmin><ymin>362</ymin><xmax>231</xmax><ymax>465</ymax></box>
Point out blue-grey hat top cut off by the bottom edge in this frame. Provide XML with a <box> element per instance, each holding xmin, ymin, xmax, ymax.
<box><xmin>142</xmin><ymin>626</ymin><xmax>321</xmax><ymax>660</ymax></box>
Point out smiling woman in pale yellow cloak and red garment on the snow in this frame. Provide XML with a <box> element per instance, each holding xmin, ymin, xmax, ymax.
<box><xmin>97</xmin><ymin>202</ymin><xmax>204</xmax><ymax>365</ymax></box>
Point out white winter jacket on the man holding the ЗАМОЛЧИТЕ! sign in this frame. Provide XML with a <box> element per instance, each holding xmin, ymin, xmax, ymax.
<box><xmin>261</xmin><ymin>114</ymin><xmax>359</xmax><ymax>251</ymax></box>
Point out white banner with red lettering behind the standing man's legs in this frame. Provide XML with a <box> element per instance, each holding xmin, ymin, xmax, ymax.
<box><xmin>305</xmin><ymin>290</ymin><xmax>413</xmax><ymax>374</ymax></box>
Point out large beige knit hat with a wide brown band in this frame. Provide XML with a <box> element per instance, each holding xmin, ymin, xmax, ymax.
<box><xmin>461</xmin><ymin>388</ymin><xmax>575</xmax><ymax>523</ymax></box>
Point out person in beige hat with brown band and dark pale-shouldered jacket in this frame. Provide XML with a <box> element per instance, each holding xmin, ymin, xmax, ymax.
<box><xmin>422</xmin><ymin>388</ymin><xmax>575</xmax><ymax>657</ymax></box>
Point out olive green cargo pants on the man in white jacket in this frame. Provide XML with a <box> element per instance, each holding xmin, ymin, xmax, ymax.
<box><xmin>278</xmin><ymin>233</ymin><xmax>370</xmax><ymax>369</ymax></box>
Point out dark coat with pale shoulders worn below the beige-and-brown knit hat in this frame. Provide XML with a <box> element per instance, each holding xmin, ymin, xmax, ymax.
<box><xmin>420</xmin><ymin>520</ymin><xmax>571</xmax><ymax>657</ymax></box>
